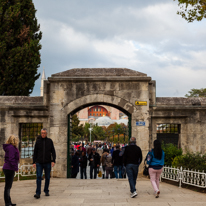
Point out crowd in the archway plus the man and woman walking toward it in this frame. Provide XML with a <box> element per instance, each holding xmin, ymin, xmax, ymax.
<box><xmin>71</xmin><ymin>137</ymin><xmax>165</xmax><ymax>198</ymax></box>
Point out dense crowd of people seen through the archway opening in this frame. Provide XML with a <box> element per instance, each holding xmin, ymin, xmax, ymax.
<box><xmin>71</xmin><ymin>143</ymin><xmax>126</xmax><ymax>179</ymax></box>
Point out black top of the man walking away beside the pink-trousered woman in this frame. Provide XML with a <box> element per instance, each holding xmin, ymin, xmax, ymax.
<box><xmin>123</xmin><ymin>145</ymin><xmax>142</xmax><ymax>166</ymax></box>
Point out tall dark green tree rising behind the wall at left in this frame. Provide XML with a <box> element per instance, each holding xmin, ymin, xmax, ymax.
<box><xmin>0</xmin><ymin>0</ymin><xmax>42</xmax><ymax>96</ymax></box>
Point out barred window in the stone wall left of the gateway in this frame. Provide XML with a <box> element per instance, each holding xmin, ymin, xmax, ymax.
<box><xmin>19</xmin><ymin>123</ymin><xmax>43</xmax><ymax>158</ymax></box>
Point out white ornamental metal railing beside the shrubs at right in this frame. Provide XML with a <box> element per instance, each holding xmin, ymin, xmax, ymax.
<box><xmin>161</xmin><ymin>166</ymin><xmax>206</xmax><ymax>188</ymax></box>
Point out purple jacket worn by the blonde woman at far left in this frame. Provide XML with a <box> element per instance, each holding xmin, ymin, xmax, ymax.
<box><xmin>3</xmin><ymin>144</ymin><xmax>19</xmax><ymax>171</ymax></box>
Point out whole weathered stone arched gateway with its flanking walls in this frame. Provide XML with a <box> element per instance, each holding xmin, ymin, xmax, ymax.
<box><xmin>0</xmin><ymin>68</ymin><xmax>206</xmax><ymax>177</ymax></box>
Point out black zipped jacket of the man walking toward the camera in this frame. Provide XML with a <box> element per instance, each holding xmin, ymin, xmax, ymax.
<box><xmin>33</xmin><ymin>137</ymin><xmax>56</xmax><ymax>164</ymax></box>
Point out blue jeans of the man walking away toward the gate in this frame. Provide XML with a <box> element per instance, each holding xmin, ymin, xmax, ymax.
<box><xmin>126</xmin><ymin>164</ymin><xmax>139</xmax><ymax>193</ymax></box>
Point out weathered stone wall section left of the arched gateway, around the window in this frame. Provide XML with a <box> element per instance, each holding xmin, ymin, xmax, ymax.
<box><xmin>0</xmin><ymin>96</ymin><xmax>49</xmax><ymax>165</ymax></box>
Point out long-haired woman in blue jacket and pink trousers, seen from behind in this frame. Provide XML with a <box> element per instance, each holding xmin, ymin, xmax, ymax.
<box><xmin>147</xmin><ymin>140</ymin><xmax>165</xmax><ymax>198</ymax></box>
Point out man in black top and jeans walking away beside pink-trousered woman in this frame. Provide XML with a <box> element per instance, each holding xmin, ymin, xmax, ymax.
<box><xmin>123</xmin><ymin>137</ymin><xmax>142</xmax><ymax>198</ymax></box>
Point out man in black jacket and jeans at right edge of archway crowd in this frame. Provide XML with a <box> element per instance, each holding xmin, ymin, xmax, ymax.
<box><xmin>112</xmin><ymin>145</ymin><xmax>123</xmax><ymax>179</ymax></box>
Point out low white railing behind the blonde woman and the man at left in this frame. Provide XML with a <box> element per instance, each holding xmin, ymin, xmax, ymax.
<box><xmin>0</xmin><ymin>164</ymin><xmax>54</xmax><ymax>181</ymax></box>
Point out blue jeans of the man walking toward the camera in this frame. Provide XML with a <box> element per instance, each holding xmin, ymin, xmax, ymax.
<box><xmin>36</xmin><ymin>163</ymin><xmax>51</xmax><ymax>195</ymax></box>
